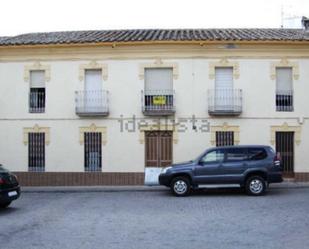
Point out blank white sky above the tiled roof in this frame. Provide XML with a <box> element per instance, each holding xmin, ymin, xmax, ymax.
<box><xmin>0</xmin><ymin>0</ymin><xmax>309</xmax><ymax>36</ymax></box>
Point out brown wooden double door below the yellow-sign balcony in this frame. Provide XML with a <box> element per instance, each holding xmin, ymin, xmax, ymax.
<box><xmin>145</xmin><ymin>131</ymin><xmax>173</xmax><ymax>167</ymax></box>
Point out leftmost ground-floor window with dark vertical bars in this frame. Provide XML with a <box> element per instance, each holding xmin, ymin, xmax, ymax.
<box><xmin>28</xmin><ymin>132</ymin><xmax>45</xmax><ymax>172</ymax></box>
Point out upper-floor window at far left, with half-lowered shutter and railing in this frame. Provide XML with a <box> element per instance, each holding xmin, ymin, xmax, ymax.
<box><xmin>29</xmin><ymin>70</ymin><xmax>45</xmax><ymax>113</ymax></box>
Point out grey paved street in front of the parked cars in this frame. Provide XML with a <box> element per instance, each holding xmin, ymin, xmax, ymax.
<box><xmin>0</xmin><ymin>188</ymin><xmax>309</xmax><ymax>249</ymax></box>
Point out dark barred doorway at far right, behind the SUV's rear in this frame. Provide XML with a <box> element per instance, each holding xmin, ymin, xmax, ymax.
<box><xmin>276</xmin><ymin>132</ymin><xmax>294</xmax><ymax>177</ymax></box>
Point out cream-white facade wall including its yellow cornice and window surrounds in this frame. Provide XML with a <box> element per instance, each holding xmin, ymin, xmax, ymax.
<box><xmin>0</xmin><ymin>42</ymin><xmax>309</xmax><ymax>184</ymax></box>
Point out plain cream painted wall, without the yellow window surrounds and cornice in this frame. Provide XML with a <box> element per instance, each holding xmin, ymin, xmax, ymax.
<box><xmin>0</xmin><ymin>55</ymin><xmax>309</xmax><ymax>172</ymax></box>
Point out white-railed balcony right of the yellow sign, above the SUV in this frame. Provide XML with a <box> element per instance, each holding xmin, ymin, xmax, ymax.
<box><xmin>208</xmin><ymin>89</ymin><xmax>242</xmax><ymax>116</ymax></box>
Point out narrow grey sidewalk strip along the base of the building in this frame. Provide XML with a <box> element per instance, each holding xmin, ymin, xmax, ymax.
<box><xmin>22</xmin><ymin>182</ymin><xmax>309</xmax><ymax>193</ymax></box>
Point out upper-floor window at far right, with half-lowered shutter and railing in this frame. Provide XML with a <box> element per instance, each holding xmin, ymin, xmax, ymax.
<box><xmin>276</xmin><ymin>67</ymin><xmax>294</xmax><ymax>112</ymax></box>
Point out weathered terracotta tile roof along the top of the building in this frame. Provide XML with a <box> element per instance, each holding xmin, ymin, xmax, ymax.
<box><xmin>0</xmin><ymin>29</ymin><xmax>309</xmax><ymax>46</ymax></box>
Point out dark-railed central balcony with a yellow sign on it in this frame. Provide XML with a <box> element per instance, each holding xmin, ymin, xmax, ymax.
<box><xmin>142</xmin><ymin>90</ymin><xmax>175</xmax><ymax>116</ymax></box>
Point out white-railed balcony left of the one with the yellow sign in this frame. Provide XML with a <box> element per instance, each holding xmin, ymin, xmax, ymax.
<box><xmin>75</xmin><ymin>91</ymin><xmax>109</xmax><ymax>117</ymax></box>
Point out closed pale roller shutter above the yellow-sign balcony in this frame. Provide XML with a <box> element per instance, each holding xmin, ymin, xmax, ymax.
<box><xmin>145</xmin><ymin>68</ymin><xmax>173</xmax><ymax>91</ymax></box>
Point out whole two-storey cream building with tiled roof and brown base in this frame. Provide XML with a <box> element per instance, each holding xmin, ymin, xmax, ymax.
<box><xmin>0</xmin><ymin>24</ymin><xmax>309</xmax><ymax>185</ymax></box>
